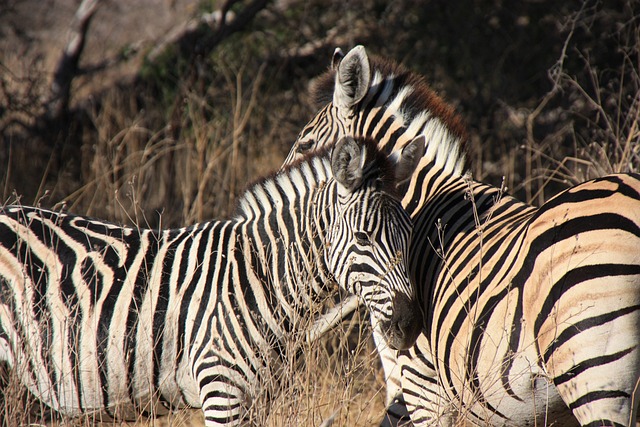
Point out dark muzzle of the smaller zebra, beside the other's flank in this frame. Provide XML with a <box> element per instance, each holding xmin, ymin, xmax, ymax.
<box><xmin>380</xmin><ymin>294</ymin><xmax>423</xmax><ymax>350</ymax></box>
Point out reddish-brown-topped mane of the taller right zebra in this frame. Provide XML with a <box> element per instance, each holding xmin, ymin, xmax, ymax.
<box><xmin>311</xmin><ymin>51</ymin><xmax>468</xmax><ymax>174</ymax></box>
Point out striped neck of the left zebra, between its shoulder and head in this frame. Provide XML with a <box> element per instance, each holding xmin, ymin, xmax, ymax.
<box><xmin>232</xmin><ymin>171</ymin><xmax>335</xmax><ymax>342</ymax></box>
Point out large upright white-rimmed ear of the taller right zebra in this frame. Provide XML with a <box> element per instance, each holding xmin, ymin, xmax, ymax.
<box><xmin>332</xmin><ymin>46</ymin><xmax>371</xmax><ymax>110</ymax></box>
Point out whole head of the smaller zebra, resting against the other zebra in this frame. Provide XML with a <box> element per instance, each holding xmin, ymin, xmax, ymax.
<box><xmin>325</xmin><ymin>137</ymin><xmax>424</xmax><ymax>349</ymax></box>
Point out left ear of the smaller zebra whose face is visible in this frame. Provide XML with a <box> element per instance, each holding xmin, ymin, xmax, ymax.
<box><xmin>331</xmin><ymin>136</ymin><xmax>366</xmax><ymax>192</ymax></box>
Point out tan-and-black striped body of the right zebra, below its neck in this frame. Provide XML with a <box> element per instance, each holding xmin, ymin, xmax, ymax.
<box><xmin>399</xmin><ymin>175</ymin><xmax>640</xmax><ymax>426</ymax></box>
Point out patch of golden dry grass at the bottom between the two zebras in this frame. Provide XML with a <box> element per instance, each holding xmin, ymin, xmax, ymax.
<box><xmin>258</xmin><ymin>316</ymin><xmax>385</xmax><ymax>427</ymax></box>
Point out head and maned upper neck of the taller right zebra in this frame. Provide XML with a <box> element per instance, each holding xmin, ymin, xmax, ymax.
<box><xmin>284</xmin><ymin>46</ymin><xmax>466</xmax><ymax>177</ymax></box>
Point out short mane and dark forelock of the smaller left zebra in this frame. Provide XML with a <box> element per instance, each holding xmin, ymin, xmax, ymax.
<box><xmin>233</xmin><ymin>137</ymin><xmax>401</xmax><ymax>217</ymax></box>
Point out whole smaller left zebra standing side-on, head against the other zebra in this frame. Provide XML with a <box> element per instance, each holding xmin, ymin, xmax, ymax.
<box><xmin>0</xmin><ymin>137</ymin><xmax>424</xmax><ymax>426</ymax></box>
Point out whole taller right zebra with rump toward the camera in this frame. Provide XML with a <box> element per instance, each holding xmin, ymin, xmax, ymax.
<box><xmin>285</xmin><ymin>46</ymin><xmax>640</xmax><ymax>426</ymax></box>
